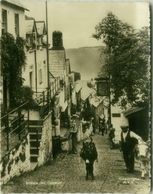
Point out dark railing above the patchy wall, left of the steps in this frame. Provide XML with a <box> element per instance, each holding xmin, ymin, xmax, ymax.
<box><xmin>0</xmin><ymin>102</ymin><xmax>29</xmax><ymax>156</ymax></box>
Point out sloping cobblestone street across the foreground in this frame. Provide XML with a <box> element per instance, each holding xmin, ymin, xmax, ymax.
<box><xmin>2</xmin><ymin>135</ymin><xmax>150</xmax><ymax>194</ymax></box>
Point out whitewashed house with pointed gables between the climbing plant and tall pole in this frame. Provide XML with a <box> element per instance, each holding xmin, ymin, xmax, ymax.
<box><xmin>22</xmin><ymin>16</ymin><xmax>48</xmax><ymax>92</ymax></box>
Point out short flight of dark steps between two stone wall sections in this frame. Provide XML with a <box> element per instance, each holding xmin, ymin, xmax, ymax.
<box><xmin>29</xmin><ymin>120</ymin><xmax>43</xmax><ymax>163</ymax></box>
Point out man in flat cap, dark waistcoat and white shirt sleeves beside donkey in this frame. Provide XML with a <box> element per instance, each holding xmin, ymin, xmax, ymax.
<box><xmin>121</xmin><ymin>125</ymin><xmax>143</xmax><ymax>173</ymax></box>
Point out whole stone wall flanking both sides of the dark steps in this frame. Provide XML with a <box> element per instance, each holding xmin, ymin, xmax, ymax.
<box><xmin>0</xmin><ymin>112</ymin><xmax>52</xmax><ymax>184</ymax></box>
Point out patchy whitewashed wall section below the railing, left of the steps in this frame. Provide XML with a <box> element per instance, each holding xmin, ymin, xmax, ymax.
<box><xmin>0</xmin><ymin>134</ymin><xmax>33</xmax><ymax>184</ymax></box>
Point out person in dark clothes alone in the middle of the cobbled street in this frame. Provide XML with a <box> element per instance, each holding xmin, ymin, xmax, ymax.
<box><xmin>80</xmin><ymin>136</ymin><xmax>98</xmax><ymax>180</ymax></box>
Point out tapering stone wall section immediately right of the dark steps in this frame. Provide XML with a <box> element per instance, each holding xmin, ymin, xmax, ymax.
<box><xmin>38</xmin><ymin>112</ymin><xmax>52</xmax><ymax>166</ymax></box>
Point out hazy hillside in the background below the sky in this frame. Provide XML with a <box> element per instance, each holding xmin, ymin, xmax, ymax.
<box><xmin>66</xmin><ymin>47</ymin><xmax>104</xmax><ymax>80</ymax></box>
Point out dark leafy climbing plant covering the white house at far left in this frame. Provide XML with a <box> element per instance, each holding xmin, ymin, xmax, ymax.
<box><xmin>1</xmin><ymin>33</ymin><xmax>26</xmax><ymax>109</ymax></box>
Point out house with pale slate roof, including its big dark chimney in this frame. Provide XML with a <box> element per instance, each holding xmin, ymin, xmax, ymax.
<box><xmin>49</xmin><ymin>31</ymin><xmax>71</xmax><ymax>130</ymax></box>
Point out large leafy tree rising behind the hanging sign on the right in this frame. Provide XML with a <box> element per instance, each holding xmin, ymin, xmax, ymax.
<box><xmin>93</xmin><ymin>13</ymin><xmax>150</xmax><ymax>107</ymax></box>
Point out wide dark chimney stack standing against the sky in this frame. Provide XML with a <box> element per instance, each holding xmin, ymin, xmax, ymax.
<box><xmin>52</xmin><ymin>31</ymin><xmax>64</xmax><ymax>50</ymax></box>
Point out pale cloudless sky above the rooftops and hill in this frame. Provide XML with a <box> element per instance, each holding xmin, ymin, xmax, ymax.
<box><xmin>19</xmin><ymin>0</ymin><xmax>149</xmax><ymax>49</ymax></box>
